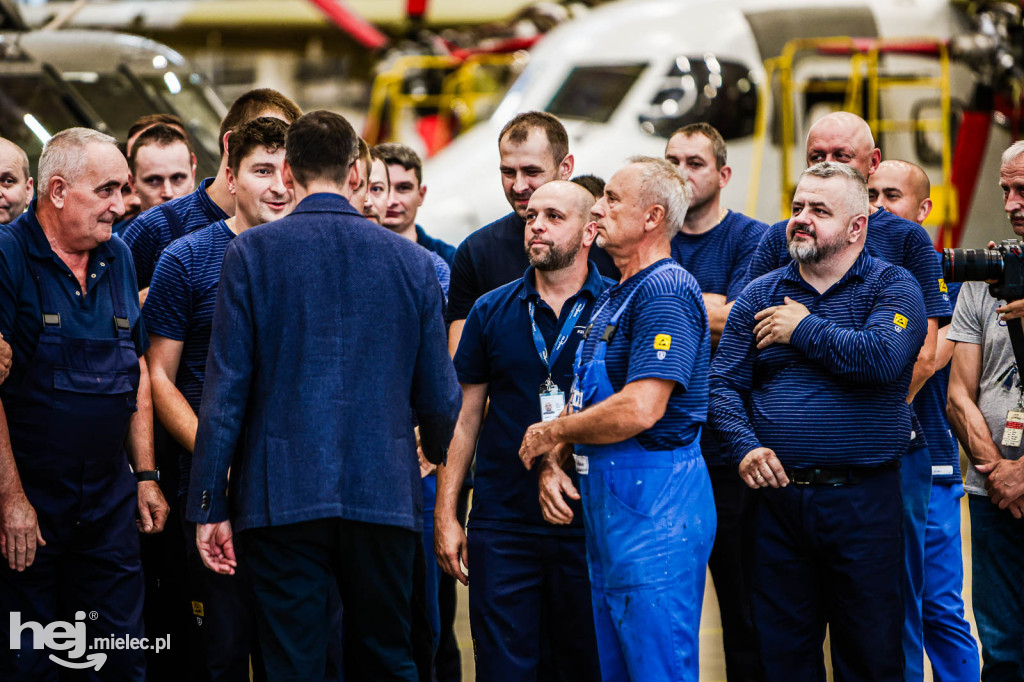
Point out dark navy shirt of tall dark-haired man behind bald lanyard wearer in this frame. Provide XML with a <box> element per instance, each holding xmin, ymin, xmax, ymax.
<box><xmin>444</xmin><ymin>211</ymin><xmax>618</xmax><ymax>323</ymax></box>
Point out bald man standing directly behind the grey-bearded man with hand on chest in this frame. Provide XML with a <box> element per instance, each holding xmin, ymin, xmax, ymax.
<box><xmin>746</xmin><ymin>112</ymin><xmax>952</xmax><ymax>682</ymax></box>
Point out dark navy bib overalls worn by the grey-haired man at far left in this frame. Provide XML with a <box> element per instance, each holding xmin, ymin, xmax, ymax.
<box><xmin>0</xmin><ymin>255</ymin><xmax>145</xmax><ymax>680</ymax></box>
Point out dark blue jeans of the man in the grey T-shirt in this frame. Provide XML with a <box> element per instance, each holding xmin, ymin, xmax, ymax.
<box><xmin>968</xmin><ymin>495</ymin><xmax>1024</xmax><ymax>682</ymax></box>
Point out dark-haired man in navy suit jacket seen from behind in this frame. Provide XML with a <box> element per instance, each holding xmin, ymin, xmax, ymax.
<box><xmin>187</xmin><ymin>112</ymin><xmax>461</xmax><ymax>682</ymax></box>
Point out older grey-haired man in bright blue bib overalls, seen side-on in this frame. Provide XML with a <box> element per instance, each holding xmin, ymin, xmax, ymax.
<box><xmin>519</xmin><ymin>157</ymin><xmax>715</xmax><ymax>681</ymax></box>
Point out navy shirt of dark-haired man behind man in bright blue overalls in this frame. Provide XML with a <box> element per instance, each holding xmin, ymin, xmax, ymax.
<box><xmin>672</xmin><ymin>211</ymin><xmax>768</xmax><ymax>301</ymax></box>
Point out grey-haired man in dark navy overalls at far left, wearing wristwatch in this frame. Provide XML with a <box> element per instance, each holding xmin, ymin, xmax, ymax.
<box><xmin>0</xmin><ymin>128</ymin><xmax>168</xmax><ymax>680</ymax></box>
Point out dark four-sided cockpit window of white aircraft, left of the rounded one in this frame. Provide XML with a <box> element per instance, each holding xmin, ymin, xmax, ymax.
<box><xmin>548</xmin><ymin>63</ymin><xmax>646</xmax><ymax>123</ymax></box>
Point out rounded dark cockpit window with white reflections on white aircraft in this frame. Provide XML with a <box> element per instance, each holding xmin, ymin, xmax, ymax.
<box><xmin>640</xmin><ymin>54</ymin><xmax>758</xmax><ymax>140</ymax></box>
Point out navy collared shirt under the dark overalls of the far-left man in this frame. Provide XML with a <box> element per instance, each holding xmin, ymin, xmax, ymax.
<box><xmin>0</xmin><ymin>201</ymin><xmax>150</xmax><ymax>397</ymax></box>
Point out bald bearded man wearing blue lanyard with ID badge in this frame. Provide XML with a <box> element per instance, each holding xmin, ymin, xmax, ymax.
<box><xmin>434</xmin><ymin>180</ymin><xmax>611</xmax><ymax>681</ymax></box>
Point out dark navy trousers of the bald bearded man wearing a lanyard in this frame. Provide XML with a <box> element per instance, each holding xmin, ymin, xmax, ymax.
<box><xmin>468</xmin><ymin>527</ymin><xmax>600</xmax><ymax>682</ymax></box>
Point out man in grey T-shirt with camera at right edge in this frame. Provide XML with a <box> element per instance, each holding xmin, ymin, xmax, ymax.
<box><xmin>946</xmin><ymin>142</ymin><xmax>1024</xmax><ymax>682</ymax></box>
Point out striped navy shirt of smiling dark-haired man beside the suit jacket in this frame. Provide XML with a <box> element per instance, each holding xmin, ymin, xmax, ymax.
<box><xmin>142</xmin><ymin>220</ymin><xmax>234</xmax><ymax>494</ymax></box>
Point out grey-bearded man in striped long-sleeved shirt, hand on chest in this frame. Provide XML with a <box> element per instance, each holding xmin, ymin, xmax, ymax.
<box><xmin>711</xmin><ymin>163</ymin><xmax>927</xmax><ymax>682</ymax></box>
